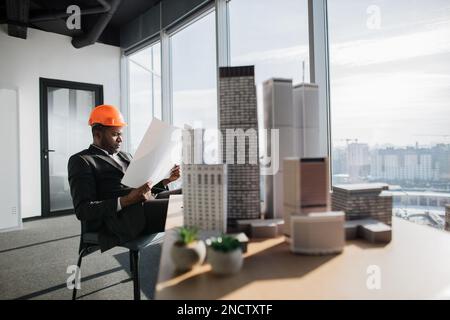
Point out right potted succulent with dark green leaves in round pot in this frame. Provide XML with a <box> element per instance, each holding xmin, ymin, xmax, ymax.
<box><xmin>208</xmin><ymin>235</ymin><xmax>244</xmax><ymax>275</ymax></box>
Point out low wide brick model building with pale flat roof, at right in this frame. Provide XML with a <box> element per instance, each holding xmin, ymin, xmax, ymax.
<box><xmin>331</xmin><ymin>183</ymin><xmax>392</xmax><ymax>226</ymax></box>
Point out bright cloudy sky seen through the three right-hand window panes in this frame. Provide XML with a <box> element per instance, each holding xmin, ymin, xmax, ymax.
<box><xmin>126</xmin><ymin>0</ymin><xmax>450</xmax><ymax>152</ymax></box>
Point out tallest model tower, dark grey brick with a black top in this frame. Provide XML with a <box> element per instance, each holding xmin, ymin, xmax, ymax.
<box><xmin>219</xmin><ymin>66</ymin><xmax>261</xmax><ymax>224</ymax></box>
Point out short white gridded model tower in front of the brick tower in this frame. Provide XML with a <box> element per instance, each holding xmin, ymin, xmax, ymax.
<box><xmin>182</xmin><ymin>164</ymin><xmax>227</xmax><ymax>233</ymax></box>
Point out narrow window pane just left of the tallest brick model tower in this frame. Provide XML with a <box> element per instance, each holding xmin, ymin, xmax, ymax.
<box><xmin>170</xmin><ymin>12</ymin><xmax>217</xmax><ymax>129</ymax></box>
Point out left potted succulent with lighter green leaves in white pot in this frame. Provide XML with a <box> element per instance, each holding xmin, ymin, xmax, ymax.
<box><xmin>171</xmin><ymin>227</ymin><xmax>206</xmax><ymax>271</ymax></box>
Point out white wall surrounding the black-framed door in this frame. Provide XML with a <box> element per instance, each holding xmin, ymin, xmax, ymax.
<box><xmin>0</xmin><ymin>25</ymin><xmax>121</xmax><ymax>218</ymax></box>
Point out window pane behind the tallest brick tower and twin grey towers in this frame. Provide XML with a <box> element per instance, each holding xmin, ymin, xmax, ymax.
<box><xmin>228</xmin><ymin>0</ymin><xmax>309</xmax><ymax>198</ymax></box>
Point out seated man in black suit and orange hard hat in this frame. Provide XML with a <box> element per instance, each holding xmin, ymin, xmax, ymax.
<box><xmin>68</xmin><ymin>105</ymin><xmax>180</xmax><ymax>252</ymax></box>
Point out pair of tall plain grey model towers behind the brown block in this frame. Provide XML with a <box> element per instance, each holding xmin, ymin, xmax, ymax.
<box><xmin>263</xmin><ymin>78</ymin><xmax>328</xmax><ymax>218</ymax></box>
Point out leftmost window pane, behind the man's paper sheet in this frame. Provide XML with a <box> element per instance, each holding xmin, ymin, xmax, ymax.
<box><xmin>128</xmin><ymin>42</ymin><xmax>162</xmax><ymax>154</ymax></box>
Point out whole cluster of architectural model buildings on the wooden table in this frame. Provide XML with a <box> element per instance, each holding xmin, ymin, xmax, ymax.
<box><xmin>179</xmin><ymin>66</ymin><xmax>392</xmax><ymax>254</ymax></box>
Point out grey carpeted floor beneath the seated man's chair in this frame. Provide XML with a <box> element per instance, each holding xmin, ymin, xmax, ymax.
<box><xmin>0</xmin><ymin>215</ymin><xmax>161</xmax><ymax>300</ymax></box>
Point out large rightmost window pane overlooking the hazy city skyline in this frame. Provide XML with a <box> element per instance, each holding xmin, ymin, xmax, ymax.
<box><xmin>328</xmin><ymin>0</ymin><xmax>450</xmax><ymax>228</ymax></box>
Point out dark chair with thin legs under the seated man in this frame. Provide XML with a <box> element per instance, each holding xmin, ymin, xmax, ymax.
<box><xmin>72</xmin><ymin>222</ymin><xmax>164</xmax><ymax>300</ymax></box>
